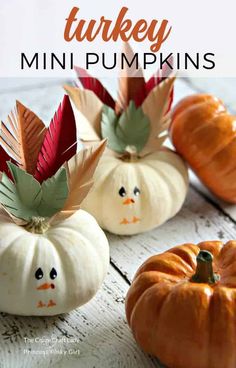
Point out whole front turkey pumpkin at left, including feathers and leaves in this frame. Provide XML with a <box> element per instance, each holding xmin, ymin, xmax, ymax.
<box><xmin>0</xmin><ymin>96</ymin><xmax>109</xmax><ymax>316</ymax></box>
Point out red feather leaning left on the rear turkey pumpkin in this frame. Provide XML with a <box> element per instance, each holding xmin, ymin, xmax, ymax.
<box><xmin>74</xmin><ymin>66</ymin><xmax>115</xmax><ymax>109</ymax></box>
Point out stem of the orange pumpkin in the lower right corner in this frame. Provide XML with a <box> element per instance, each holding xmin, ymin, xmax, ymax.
<box><xmin>191</xmin><ymin>250</ymin><xmax>220</xmax><ymax>284</ymax></box>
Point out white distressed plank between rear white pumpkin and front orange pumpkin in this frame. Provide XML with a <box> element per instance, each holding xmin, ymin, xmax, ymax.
<box><xmin>108</xmin><ymin>188</ymin><xmax>236</xmax><ymax>281</ymax></box>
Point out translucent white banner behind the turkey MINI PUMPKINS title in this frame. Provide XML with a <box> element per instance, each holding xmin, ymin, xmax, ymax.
<box><xmin>0</xmin><ymin>0</ymin><xmax>236</xmax><ymax>77</ymax></box>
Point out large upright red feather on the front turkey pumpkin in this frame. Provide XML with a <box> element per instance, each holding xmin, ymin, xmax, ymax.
<box><xmin>34</xmin><ymin>95</ymin><xmax>77</xmax><ymax>183</ymax></box>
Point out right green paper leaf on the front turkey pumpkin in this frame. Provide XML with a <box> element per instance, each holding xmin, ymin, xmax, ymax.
<box><xmin>38</xmin><ymin>167</ymin><xmax>69</xmax><ymax>217</ymax></box>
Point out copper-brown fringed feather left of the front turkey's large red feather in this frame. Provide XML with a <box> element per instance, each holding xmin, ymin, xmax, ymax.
<box><xmin>0</xmin><ymin>101</ymin><xmax>46</xmax><ymax>174</ymax></box>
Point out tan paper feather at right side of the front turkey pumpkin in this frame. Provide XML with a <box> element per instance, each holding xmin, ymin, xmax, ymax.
<box><xmin>53</xmin><ymin>140</ymin><xmax>106</xmax><ymax>221</ymax></box>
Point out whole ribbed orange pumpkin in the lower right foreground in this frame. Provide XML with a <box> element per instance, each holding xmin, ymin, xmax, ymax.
<box><xmin>126</xmin><ymin>241</ymin><xmax>236</xmax><ymax>368</ymax></box>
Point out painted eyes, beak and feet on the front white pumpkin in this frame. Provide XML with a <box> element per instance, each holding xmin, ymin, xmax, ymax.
<box><xmin>34</xmin><ymin>267</ymin><xmax>57</xmax><ymax>308</ymax></box>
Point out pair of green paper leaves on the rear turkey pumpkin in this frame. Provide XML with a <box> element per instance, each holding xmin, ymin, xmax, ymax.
<box><xmin>101</xmin><ymin>101</ymin><xmax>151</xmax><ymax>153</ymax></box>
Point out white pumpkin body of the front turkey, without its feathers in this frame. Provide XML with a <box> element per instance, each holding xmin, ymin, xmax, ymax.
<box><xmin>0</xmin><ymin>210</ymin><xmax>109</xmax><ymax>316</ymax></box>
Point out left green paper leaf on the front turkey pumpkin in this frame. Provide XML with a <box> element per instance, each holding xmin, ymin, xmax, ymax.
<box><xmin>0</xmin><ymin>162</ymin><xmax>42</xmax><ymax>221</ymax></box>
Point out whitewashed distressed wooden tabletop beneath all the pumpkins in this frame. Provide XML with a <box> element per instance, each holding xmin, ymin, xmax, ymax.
<box><xmin>0</xmin><ymin>79</ymin><xmax>236</xmax><ymax>368</ymax></box>
